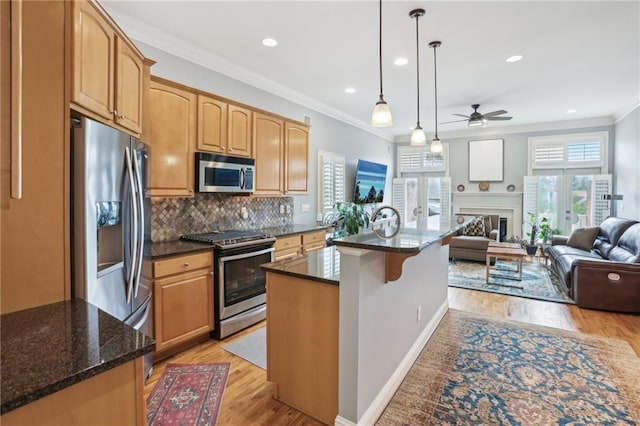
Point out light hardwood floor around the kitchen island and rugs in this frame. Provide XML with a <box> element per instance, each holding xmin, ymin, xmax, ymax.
<box><xmin>144</xmin><ymin>287</ymin><xmax>640</xmax><ymax>425</ymax></box>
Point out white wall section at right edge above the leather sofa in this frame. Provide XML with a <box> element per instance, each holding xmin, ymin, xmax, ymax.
<box><xmin>613</xmin><ymin>105</ymin><xmax>640</xmax><ymax>220</ymax></box>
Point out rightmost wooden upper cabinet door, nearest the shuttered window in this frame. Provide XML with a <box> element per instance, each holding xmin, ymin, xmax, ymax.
<box><xmin>284</xmin><ymin>122</ymin><xmax>309</xmax><ymax>193</ymax></box>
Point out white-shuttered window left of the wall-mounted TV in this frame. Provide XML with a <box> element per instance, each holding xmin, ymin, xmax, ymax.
<box><xmin>318</xmin><ymin>150</ymin><xmax>345</xmax><ymax>219</ymax></box>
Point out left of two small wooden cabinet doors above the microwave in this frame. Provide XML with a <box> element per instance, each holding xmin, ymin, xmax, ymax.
<box><xmin>197</xmin><ymin>95</ymin><xmax>227</xmax><ymax>154</ymax></box>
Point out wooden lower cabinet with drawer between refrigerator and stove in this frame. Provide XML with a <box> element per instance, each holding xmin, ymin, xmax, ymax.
<box><xmin>143</xmin><ymin>250</ymin><xmax>214</xmax><ymax>359</ymax></box>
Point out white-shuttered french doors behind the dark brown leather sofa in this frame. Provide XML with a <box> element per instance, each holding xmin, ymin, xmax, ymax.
<box><xmin>523</xmin><ymin>169</ymin><xmax>611</xmax><ymax>235</ymax></box>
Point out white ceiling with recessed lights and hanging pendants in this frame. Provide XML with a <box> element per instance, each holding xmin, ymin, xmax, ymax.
<box><xmin>101</xmin><ymin>0</ymin><xmax>640</xmax><ymax>140</ymax></box>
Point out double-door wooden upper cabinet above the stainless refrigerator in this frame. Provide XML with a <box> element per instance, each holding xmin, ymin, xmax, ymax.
<box><xmin>71</xmin><ymin>1</ymin><xmax>144</xmax><ymax>136</ymax></box>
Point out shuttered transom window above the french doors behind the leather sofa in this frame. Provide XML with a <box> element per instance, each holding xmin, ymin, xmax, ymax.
<box><xmin>529</xmin><ymin>132</ymin><xmax>609</xmax><ymax>174</ymax></box>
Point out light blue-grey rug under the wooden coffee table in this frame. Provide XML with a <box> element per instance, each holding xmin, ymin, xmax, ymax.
<box><xmin>449</xmin><ymin>259</ymin><xmax>575</xmax><ymax>304</ymax></box>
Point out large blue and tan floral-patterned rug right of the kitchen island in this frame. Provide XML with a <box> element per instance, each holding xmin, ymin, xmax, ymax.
<box><xmin>378</xmin><ymin>309</ymin><xmax>640</xmax><ymax>426</ymax></box>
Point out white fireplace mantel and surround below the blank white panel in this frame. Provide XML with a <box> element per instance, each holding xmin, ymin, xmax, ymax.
<box><xmin>453</xmin><ymin>191</ymin><xmax>522</xmax><ymax>237</ymax></box>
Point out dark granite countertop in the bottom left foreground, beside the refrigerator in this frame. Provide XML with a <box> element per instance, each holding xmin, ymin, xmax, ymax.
<box><xmin>0</xmin><ymin>299</ymin><xmax>155</xmax><ymax>414</ymax></box>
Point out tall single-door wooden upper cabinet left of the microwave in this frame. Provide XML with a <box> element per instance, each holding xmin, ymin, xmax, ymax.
<box><xmin>148</xmin><ymin>78</ymin><xmax>197</xmax><ymax>197</ymax></box>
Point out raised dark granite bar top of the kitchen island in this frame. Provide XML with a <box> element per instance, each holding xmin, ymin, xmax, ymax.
<box><xmin>333</xmin><ymin>215</ymin><xmax>474</xmax><ymax>253</ymax></box>
